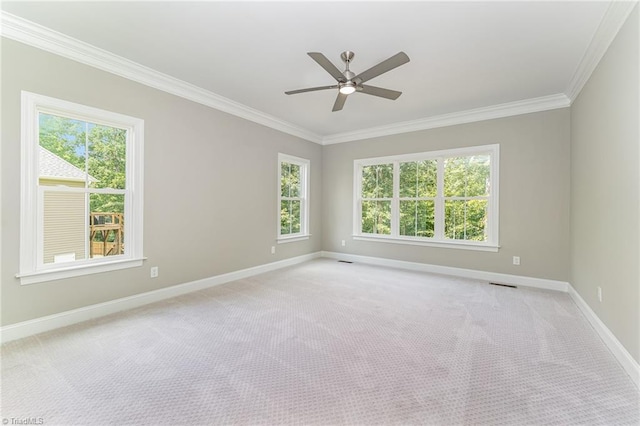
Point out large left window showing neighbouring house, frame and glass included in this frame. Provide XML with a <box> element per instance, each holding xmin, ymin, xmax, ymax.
<box><xmin>18</xmin><ymin>92</ymin><xmax>144</xmax><ymax>284</ymax></box>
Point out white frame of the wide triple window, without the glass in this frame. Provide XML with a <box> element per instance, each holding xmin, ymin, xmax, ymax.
<box><xmin>353</xmin><ymin>144</ymin><xmax>500</xmax><ymax>252</ymax></box>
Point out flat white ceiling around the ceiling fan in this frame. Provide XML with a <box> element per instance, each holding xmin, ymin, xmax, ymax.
<box><xmin>2</xmin><ymin>1</ymin><xmax>609</xmax><ymax>142</ymax></box>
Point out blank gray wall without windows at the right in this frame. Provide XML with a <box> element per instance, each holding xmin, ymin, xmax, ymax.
<box><xmin>571</xmin><ymin>6</ymin><xmax>640</xmax><ymax>362</ymax></box>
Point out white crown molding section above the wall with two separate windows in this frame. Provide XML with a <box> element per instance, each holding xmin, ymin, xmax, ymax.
<box><xmin>0</xmin><ymin>11</ymin><xmax>322</xmax><ymax>143</ymax></box>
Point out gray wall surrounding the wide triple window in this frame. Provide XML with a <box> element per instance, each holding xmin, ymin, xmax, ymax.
<box><xmin>322</xmin><ymin>108</ymin><xmax>570</xmax><ymax>281</ymax></box>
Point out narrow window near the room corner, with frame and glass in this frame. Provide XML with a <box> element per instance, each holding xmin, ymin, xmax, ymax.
<box><xmin>278</xmin><ymin>154</ymin><xmax>309</xmax><ymax>242</ymax></box>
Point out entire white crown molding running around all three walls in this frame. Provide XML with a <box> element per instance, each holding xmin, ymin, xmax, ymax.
<box><xmin>0</xmin><ymin>7</ymin><xmax>616</xmax><ymax>145</ymax></box>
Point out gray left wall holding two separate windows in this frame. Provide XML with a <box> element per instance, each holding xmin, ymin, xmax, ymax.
<box><xmin>0</xmin><ymin>39</ymin><xmax>322</xmax><ymax>325</ymax></box>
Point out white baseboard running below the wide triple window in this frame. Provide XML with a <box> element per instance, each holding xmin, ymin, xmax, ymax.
<box><xmin>322</xmin><ymin>251</ymin><xmax>569</xmax><ymax>293</ymax></box>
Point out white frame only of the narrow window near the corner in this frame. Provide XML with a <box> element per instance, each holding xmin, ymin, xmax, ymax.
<box><xmin>277</xmin><ymin>153</ymin><xmax>311</xmax><ymax>244</ymax></box>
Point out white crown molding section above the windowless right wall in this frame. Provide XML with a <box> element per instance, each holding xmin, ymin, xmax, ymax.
<box><xmin>565</xmin><ymin>0</ymin><xmax>638</xmax><ymax>102</ymax></box>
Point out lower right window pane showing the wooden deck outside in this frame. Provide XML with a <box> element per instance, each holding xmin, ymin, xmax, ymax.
<box><xmin>89</xmin><ymin>194</ymin><xmax>125</xmax><ymax>258</ymax></box>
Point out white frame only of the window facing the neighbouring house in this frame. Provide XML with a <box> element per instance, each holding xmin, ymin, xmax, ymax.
<box><xmin>16</xmin><ymin>91</ymin><xmax>144</xmax><ymax>284</ymax></box>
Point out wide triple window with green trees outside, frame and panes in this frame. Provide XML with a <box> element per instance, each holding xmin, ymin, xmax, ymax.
<box><xmin>354</xmin><ymin>145</ymin><xmax>499</xmax><ymax>251</ymax></box>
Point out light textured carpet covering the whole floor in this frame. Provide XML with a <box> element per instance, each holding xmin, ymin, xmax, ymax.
<box><xmin>2</xmin><ymin>259</ymin><xmax>640</xmax><ymax>425</ymax></box>
